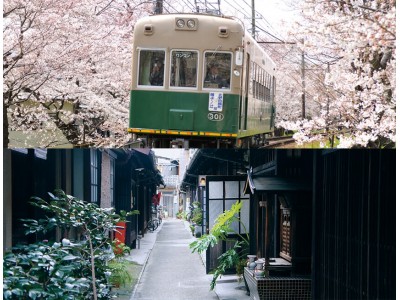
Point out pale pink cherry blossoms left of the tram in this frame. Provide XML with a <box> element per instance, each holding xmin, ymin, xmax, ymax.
<box><xmin>3</xmin><ymin>0</ymin><xmax>152</xmax><ymax>147</ymax></box>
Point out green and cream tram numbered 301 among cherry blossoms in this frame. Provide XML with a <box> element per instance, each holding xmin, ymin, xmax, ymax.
<box><xmin>128</xmin><ymin>14</ymin><xmax>275</xmax><ymax>148</ymax></box>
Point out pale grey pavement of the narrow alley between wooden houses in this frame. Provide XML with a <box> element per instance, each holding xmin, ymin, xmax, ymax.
<box><xmin>131</xmin><ymin>220</ymin><xmax>218</xmax><ymax>300</ymax></box>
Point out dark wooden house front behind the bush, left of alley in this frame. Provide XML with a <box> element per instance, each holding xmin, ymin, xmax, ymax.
<box><xmin>3</xmin><ymin>149</ymin><xmax>163</xmax><ymax>250</ymax></box>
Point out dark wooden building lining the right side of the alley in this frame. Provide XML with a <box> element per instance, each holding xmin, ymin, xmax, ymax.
<box><xmin>182</xmin><ymin>149</ymin><xmax>396</xmax><ymax>299</ymax></box>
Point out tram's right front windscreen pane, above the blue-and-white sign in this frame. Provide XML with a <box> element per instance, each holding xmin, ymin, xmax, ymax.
<box><xmin>204</xmin><ymin>52</ymin><xmax>232</xmax><ymax>89</ymax></box>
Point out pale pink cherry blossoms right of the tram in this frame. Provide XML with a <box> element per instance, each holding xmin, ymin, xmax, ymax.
<box><xmin>280</xmin><ymin>0</ymin><xmax>396</xmax><ymax>148</ymax></box>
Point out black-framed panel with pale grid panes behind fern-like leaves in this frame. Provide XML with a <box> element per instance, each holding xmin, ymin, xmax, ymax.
<box><xmin>206</xmin><ymin>176</ymin><xmax>250</xmax><ymax>273</ymax></box>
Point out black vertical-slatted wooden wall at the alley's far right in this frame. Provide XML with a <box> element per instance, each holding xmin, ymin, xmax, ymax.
<box><xmin>312</xmin><ymin>150</ymin><xmax>396</xmax><ymax>299</ymax></box>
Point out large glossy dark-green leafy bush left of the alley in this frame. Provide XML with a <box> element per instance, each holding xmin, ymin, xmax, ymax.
<box><xmin>3</xmin><ymin>190</ymin><xmax>138</xmax><ymax>300</ymax></box>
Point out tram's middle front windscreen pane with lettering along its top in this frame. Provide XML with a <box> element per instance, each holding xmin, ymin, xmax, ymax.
<box><xmin>170</xmin><ymin>50</ymin><xmax>198</xmax><ymax>87</ymax></box>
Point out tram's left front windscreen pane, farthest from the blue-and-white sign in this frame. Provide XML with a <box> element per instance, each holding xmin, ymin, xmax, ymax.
<box><xmin>138</xmin><ymin>50</ymin><xmax>165</xmax><ymax>86</ymax></box>
